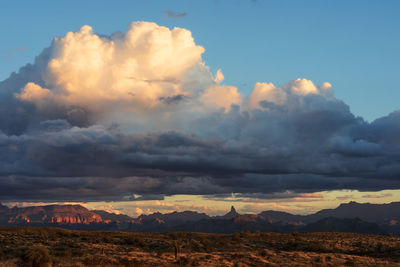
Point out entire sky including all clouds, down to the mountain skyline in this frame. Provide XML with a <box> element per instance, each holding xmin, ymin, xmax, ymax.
<box><xmin>0</xmin><ymin>0</ymin><xmax>400</xmax><ymax>216</ymax></box>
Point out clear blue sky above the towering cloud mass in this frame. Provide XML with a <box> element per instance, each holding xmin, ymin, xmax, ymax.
<box><xmin>0</xmin><ymin>0</ymin><xmax>400</xmax><ymax>121</ymax></box>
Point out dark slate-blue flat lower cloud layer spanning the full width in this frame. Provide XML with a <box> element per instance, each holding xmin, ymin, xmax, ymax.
<box><xmin>0</xmin><ymin>103</ymin><xmax>400</xmax><ymax>201</ymax></box>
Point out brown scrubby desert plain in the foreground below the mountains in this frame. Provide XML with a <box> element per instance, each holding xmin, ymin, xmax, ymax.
<box><xmin>0</xmin><ymin>226</ymin><xmax>400</xmax><ymax>267</ymax></box>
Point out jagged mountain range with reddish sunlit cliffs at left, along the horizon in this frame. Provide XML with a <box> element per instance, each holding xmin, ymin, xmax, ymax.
<box><xmin>0</xmin><ymin>202</ymin><xmax>400</xmax><ymax>235</ymax></box>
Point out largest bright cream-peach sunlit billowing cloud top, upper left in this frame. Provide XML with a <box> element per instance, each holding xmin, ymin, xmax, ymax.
<box><xmin>12</xmin><ymin>22</ymin><xmax>206</xmax><ymax>113</ymax></box>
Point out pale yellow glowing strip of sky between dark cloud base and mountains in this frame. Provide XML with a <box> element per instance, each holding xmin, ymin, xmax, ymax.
<box><xmin>4</xmin><ymin>190</ymin><xmax>400</xmax><ymax>217</ymax></box>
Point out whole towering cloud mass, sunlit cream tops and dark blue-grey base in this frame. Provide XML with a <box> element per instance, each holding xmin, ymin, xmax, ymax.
<box><xmin>0</xmin><ymin>22</ymin><xmax>400</xmax><ymax>201</ymax></box>
